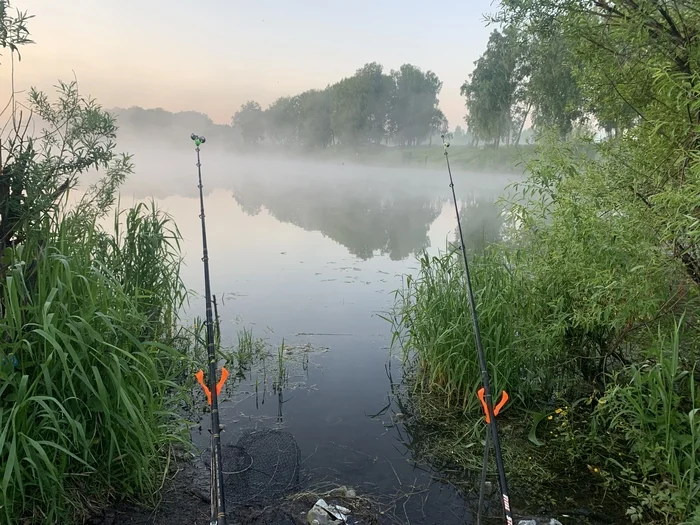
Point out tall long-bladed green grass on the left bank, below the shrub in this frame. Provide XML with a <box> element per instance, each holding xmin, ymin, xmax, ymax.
<box><xmin>0</xmin><ymin>200</ymin><xmax>185</xmax><ymax>523</ymax></box>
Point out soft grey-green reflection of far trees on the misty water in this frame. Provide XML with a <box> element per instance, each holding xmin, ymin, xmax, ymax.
<box><xmin>233</xmin><ymin>169</ymin><xmax>502</xmax><ymax>261</ymax></box>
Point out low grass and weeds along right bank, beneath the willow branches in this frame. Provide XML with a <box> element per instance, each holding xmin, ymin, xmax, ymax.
<box><xmin>386</xmin><ymin>245</ymin><xmax>700</xmax><ymax>523</ymax></box>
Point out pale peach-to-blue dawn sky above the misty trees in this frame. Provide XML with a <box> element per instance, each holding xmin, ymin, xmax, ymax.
<box><xmin>0</xmin><ymin>0</ymin><xmax>497</xmax><ymax>128</ymax></box>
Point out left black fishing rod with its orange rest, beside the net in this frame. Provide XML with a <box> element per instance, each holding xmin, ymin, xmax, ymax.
<box><xmin>191</xmin><ymin>133</ymin><xmax>226</xmax><ymax>525</ymax></box>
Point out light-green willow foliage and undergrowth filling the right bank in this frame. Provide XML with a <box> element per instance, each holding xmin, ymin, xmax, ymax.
<box><xmin>400</xmin><ymin>0</ymin><xmax>700</xmax><ymax>523</ymax></box>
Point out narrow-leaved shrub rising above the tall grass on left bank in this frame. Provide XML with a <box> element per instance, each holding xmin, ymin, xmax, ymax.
<box><xmin>0</xmin><ymin>82</ymin><xmax>132</xmax><ymax>255</ymax></box>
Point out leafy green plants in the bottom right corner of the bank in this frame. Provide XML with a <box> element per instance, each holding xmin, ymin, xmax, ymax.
<box><xmin>595</xmin><ymin>325</ymin><xmax>700</xmax><ymax>522</ymax></box>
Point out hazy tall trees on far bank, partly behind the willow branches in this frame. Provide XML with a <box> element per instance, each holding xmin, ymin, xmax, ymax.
<box><xmin>461</xmin><ymin>12</ymin><xmax>637</xmax><ymax>147</ymax></box>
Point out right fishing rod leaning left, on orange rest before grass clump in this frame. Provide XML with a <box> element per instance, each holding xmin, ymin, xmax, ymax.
<box><xmin>442</xmin><ymin>135</ymin><xmax>513</xmax><ymax>525</ymax></box>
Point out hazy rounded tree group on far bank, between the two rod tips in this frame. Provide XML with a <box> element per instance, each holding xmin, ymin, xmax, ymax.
<box><xmin>231</xmin><ymin>62</ymin><xmax>448</xmax><ymax>148</ymax></box>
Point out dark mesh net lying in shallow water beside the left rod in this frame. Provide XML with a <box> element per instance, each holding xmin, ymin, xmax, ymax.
<box><xmin>202</xmin><ymin>429</ymin><xmax>301</xmax><ymax>506</ymax></box>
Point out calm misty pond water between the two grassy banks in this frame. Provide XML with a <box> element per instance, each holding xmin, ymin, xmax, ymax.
<box><xmin>117</xmin><ymin>155</ymin><xmax>509</xmax><ymax>524</ymax></box>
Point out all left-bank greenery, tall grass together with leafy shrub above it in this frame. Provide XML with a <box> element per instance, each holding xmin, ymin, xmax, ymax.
<box><xmin>0</xmin><ymin>16</ymin><xmax>188</xmax><ymax>525</ymax></box>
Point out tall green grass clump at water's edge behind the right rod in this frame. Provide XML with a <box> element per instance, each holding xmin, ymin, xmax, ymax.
<box><xmin>394</xmin><ymin>248</ymin><xmax>533</xmax><ymax>409</ymax></box>
